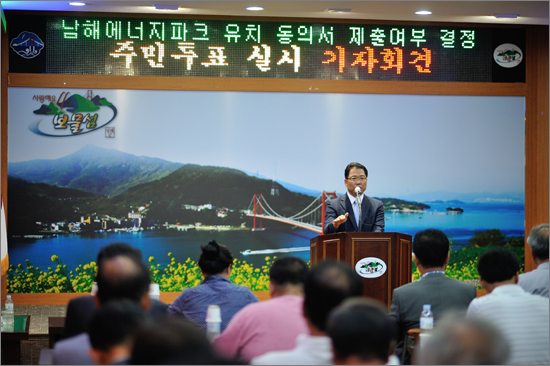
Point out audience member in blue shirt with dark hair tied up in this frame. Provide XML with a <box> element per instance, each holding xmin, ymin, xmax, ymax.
<box><xmin>168</xmin><ymin>240</ymin><xmax>258</xmax><ymax>332</ymax></box>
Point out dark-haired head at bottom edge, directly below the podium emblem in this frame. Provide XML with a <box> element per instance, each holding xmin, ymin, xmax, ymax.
<box><xmin>327</xmin><ymin>297</ymin><xmax>397</xmax><ymax>364</ymax></box>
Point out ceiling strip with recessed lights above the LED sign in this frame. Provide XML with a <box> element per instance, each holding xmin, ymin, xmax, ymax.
<box><xmin>2</xmin><ymin>0</ymin><xmax>549</xmax><ymax>25</ymax></box>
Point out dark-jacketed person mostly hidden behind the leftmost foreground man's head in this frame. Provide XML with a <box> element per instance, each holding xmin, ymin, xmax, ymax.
<box><xmin>63</xmin><ymin>243</ymin><xmax>168</xmax><ymax>338</ymax></box>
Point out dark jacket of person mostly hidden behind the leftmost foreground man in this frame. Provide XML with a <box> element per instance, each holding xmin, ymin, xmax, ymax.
<box><xmin>63</xmin><ymin>296</ymin><xmax>168</xmax><ymax>338</ymax></box>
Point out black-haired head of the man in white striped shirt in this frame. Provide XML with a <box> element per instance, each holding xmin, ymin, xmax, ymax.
<box><xmin>477</xmin><ymin>248</ymin><xmax>519</xmax><ymax>283</ymax></box>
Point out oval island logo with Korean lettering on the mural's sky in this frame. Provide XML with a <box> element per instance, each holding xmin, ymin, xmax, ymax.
<box><xmin>29</xmin><ymin>90</ymin><xmax>117</xmax><ymax>137</ymax></box>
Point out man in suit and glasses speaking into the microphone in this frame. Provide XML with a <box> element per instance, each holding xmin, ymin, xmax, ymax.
<box><xmin>323</xmin><ymin>163</ymin><xmax>385</xmax><ymax>234</ymax></box>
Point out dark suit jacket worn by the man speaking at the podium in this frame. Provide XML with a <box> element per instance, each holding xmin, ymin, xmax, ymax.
<box><xmin>323</xmin><ymin>193</ymin><xmax>385</xmax><ymax>234</ymax></box>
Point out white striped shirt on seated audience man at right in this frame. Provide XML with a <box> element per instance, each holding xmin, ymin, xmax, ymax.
<box><xmin>467</xmin><ymin>285</ymin><xmax>550</xmax><ymax>365</ymax></box>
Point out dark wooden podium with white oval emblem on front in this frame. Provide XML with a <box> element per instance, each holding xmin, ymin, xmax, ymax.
<box><xmin>310</xmin><ymin>232</ymin><xmax>412</xmax><ymax>310</ymax></box>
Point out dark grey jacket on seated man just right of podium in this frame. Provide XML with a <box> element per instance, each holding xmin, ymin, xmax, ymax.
<box><xmin>389</xmin><ymin>273</ymin><xmax>477</xmax><ymax>356</ymax></box>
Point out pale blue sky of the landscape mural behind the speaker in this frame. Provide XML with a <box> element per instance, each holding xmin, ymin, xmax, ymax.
<box><xmin>8</xmin><ymin>88</ymin><xmax>525</xmax><ymax>197</ymax></box>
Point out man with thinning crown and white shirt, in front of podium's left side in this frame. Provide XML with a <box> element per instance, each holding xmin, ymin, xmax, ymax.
<box><xmin>251</xmin><ymin>261</ymin><xmax>363</xmax><ymax>365</ymax></box>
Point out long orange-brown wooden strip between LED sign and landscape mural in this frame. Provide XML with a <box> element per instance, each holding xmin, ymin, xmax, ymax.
<box><xmin>8</xmin><ymin>73</ymin><xmax>526</xmax><ymax>96</ymax></box>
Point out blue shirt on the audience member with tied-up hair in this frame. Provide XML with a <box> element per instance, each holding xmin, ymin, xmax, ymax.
<box><xmin>168</xmin><ymin>275</ymin><xmax>258</xmax><ymax>332</ymax></box>
